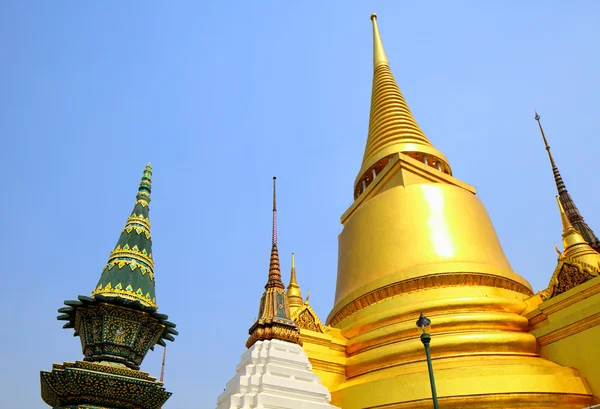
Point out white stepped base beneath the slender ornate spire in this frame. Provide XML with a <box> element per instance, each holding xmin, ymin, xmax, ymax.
<box><xmin>217</xmin><ymin>339</ymin><xmax>338</xmax><ymax>409</ymax></box>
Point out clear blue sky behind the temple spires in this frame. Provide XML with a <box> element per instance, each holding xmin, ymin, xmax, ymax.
<box><xmin>0</xmin><ymin>0</ymin><xmax>600</xmax><ymax>409</ymax></box>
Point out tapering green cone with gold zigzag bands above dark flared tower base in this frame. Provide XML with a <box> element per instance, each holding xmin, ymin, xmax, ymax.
<box><xmin>92</xmin><ymin>164</ymin><xmax>157</xmax><ymax>308</ymax></box>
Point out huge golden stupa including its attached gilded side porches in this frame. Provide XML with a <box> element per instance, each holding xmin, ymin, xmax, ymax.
<box><xmin>288</xmin><ymin>15</ymin><xmax>600</xmax><ymax>409</ymax></box>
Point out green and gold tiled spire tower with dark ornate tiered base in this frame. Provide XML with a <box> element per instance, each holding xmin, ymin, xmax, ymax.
<box><xmin>40</xmin><ymin>164</ymin><xmax>178</xmax><ymax>409</ymax></box>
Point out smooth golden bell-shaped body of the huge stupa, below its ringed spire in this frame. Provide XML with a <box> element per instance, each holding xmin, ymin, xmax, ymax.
<box><xmin>328</xmin><ymin>180</ymin><xmax>532</xmax><ymax>314</ymax></box>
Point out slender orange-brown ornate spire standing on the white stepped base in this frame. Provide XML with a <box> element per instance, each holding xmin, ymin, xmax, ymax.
<box><xmin>246</xmin><ymin>177</ymin><xmax>302</xmax><ymax>348</ymax></box>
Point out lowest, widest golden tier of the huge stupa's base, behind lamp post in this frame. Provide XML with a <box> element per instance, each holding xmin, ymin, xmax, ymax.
<box><xmin>332</xmin><ymin>356</ymin><xmax>592</xmax><ymax>409</ymax></box>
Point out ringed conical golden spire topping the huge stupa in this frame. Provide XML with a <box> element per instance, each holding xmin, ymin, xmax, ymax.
<box><xmin>355</xmin><ymin>14</ymin><xmax>451</xmax><ymax>191</ymax></box>
